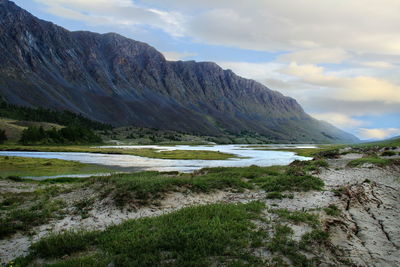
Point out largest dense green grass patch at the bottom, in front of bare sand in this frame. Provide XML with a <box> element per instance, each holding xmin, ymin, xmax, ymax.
<box><xmin>16</xmin><ymin>202</ymin><xmax>265</xmax><ymax>266</ymax></box>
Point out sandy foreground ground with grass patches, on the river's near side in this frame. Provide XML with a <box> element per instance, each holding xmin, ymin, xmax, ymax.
<box><xmin>0</xmin><ymin>153</ymin><xmax>400</xmax><ymax>266</ymax></box>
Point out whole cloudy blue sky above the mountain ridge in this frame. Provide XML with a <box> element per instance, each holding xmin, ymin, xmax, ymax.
<box><xmin>14</xmin><ymin>0</ymin><xmax>400</xmax><ymax>140</ymax></box>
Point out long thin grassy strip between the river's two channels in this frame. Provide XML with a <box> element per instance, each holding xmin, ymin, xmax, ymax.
<box><xmin>0</xmin><ymin>145</ymin><xmax>237</xmax><ymax>160</ymax></box>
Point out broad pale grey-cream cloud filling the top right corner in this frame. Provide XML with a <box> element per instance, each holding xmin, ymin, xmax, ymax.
<box><xmin>145</xmin><ymin>0</ymin><xmax>400</xmax><ymax>55</ymax></box>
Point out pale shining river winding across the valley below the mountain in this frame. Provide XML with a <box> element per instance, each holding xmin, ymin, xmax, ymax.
<box><xmin>0</xmin><ymin>145</ymin><xmax>315</xmax><ymax>177</ymax></box>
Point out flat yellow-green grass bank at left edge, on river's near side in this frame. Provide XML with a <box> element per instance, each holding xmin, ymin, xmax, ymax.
<box><xmin>0</xmin><ymin>156</ymin><xmax>110</xmax><ymax>177</ymax></box>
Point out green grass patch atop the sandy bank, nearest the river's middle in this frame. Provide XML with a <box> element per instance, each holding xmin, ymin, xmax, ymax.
<box><xmin>87</xmin><ymin>166</ymin><xmax>324</xmax><ymax>207</ymax></box>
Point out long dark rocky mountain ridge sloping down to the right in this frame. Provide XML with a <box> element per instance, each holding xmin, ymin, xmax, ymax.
<box><xmin>0</xmin><ymin>0</ymin><xmax>358</xmax><ymax>143</ymax></box>
